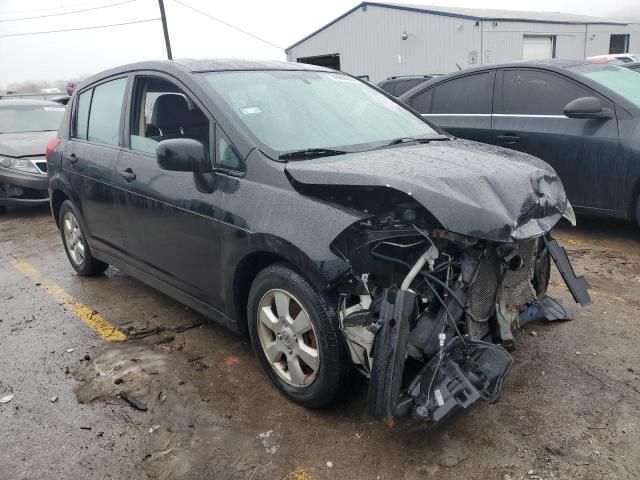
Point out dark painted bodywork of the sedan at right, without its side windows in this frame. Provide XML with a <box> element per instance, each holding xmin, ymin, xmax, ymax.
<box><xmin>400</xmin><ymin>60</ymin><xmax>640</xmax><ymax>219</ymax></box>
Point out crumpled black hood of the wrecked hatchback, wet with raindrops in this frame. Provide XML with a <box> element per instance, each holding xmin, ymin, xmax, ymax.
<box><xmin>286</xmin><ymin>140</ymin><xmax>567</xmax><ymax>242</ymax></box>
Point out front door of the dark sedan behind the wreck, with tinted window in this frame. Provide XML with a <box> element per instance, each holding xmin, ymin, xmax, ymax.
<box><xmin>492</xmin><ymin>68</ymin><xmax>621</xmax><ymax>210</ymax></box>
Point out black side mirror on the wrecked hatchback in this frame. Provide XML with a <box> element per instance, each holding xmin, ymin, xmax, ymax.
<box><xmin>156</xmin><ymin>138</ymin><xmax>213</xmax><ymax>173</ymax></box>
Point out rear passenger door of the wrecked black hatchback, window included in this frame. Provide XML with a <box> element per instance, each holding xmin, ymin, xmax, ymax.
<box><xmin>62</xmin><ymin>76</ymin><xmax>128</xmax><ymax>255</ymax></box>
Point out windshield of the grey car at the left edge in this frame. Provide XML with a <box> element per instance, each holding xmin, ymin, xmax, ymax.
<box><xmin>0</xmin><ymin>105</ymin><xmax>64</xmax><ymax>133</ymax></box>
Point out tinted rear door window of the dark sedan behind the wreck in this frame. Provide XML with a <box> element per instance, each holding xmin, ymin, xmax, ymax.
<box><xmin>430</xmin><ymin>72</ymin><xmax>494</xmax><ymax>115</ymax></box>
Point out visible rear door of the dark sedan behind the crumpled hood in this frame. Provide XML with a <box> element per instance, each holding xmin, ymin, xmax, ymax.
<box><xmin>409</xmin><ymin>71</ymin><xmax>495</xmax><ymax>143</ymax></box>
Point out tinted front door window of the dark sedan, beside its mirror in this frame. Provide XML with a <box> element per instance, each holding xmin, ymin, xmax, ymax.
<box><xmin>502</xmin><ymin>70</ymin><xmax>593</xmax><ymax>115</ymax></box>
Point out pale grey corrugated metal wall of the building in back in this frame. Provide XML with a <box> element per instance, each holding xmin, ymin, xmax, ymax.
<box><xmin>287</xmin><ymin>5</ymin><xmax>640</xmax><ymax>82</ymax></box>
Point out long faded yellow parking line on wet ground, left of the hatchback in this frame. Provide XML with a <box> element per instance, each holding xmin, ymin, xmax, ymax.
<box><xmin>9</xmin><ymin>259</ymin><xmax>127</xmax><ymax>342</ymax></box>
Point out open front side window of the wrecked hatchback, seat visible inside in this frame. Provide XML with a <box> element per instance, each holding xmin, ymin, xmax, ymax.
<box><xmin>130</xmin><ymin>77</ymin><xmax>209</xmax><ymax>155</ymax></box>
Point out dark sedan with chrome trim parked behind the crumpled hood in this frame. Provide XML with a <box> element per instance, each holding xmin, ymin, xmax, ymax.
<box><xmin>401</xmin><ymin>60</ymin><xmax>640</xmax><ymax>224</ymax></box>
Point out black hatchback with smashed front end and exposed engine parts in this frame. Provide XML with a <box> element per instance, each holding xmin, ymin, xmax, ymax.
<box><xmin>47</xmin><ymin>60</ymin><xmax>589</xmax><ymax>421</ymax></box>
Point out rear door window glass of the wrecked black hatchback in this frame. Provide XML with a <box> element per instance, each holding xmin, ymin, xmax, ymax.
<box><xmin>87</xmin><ymin>78</ymin><xmax>127</xmax><ymax>145</ymax></box>
